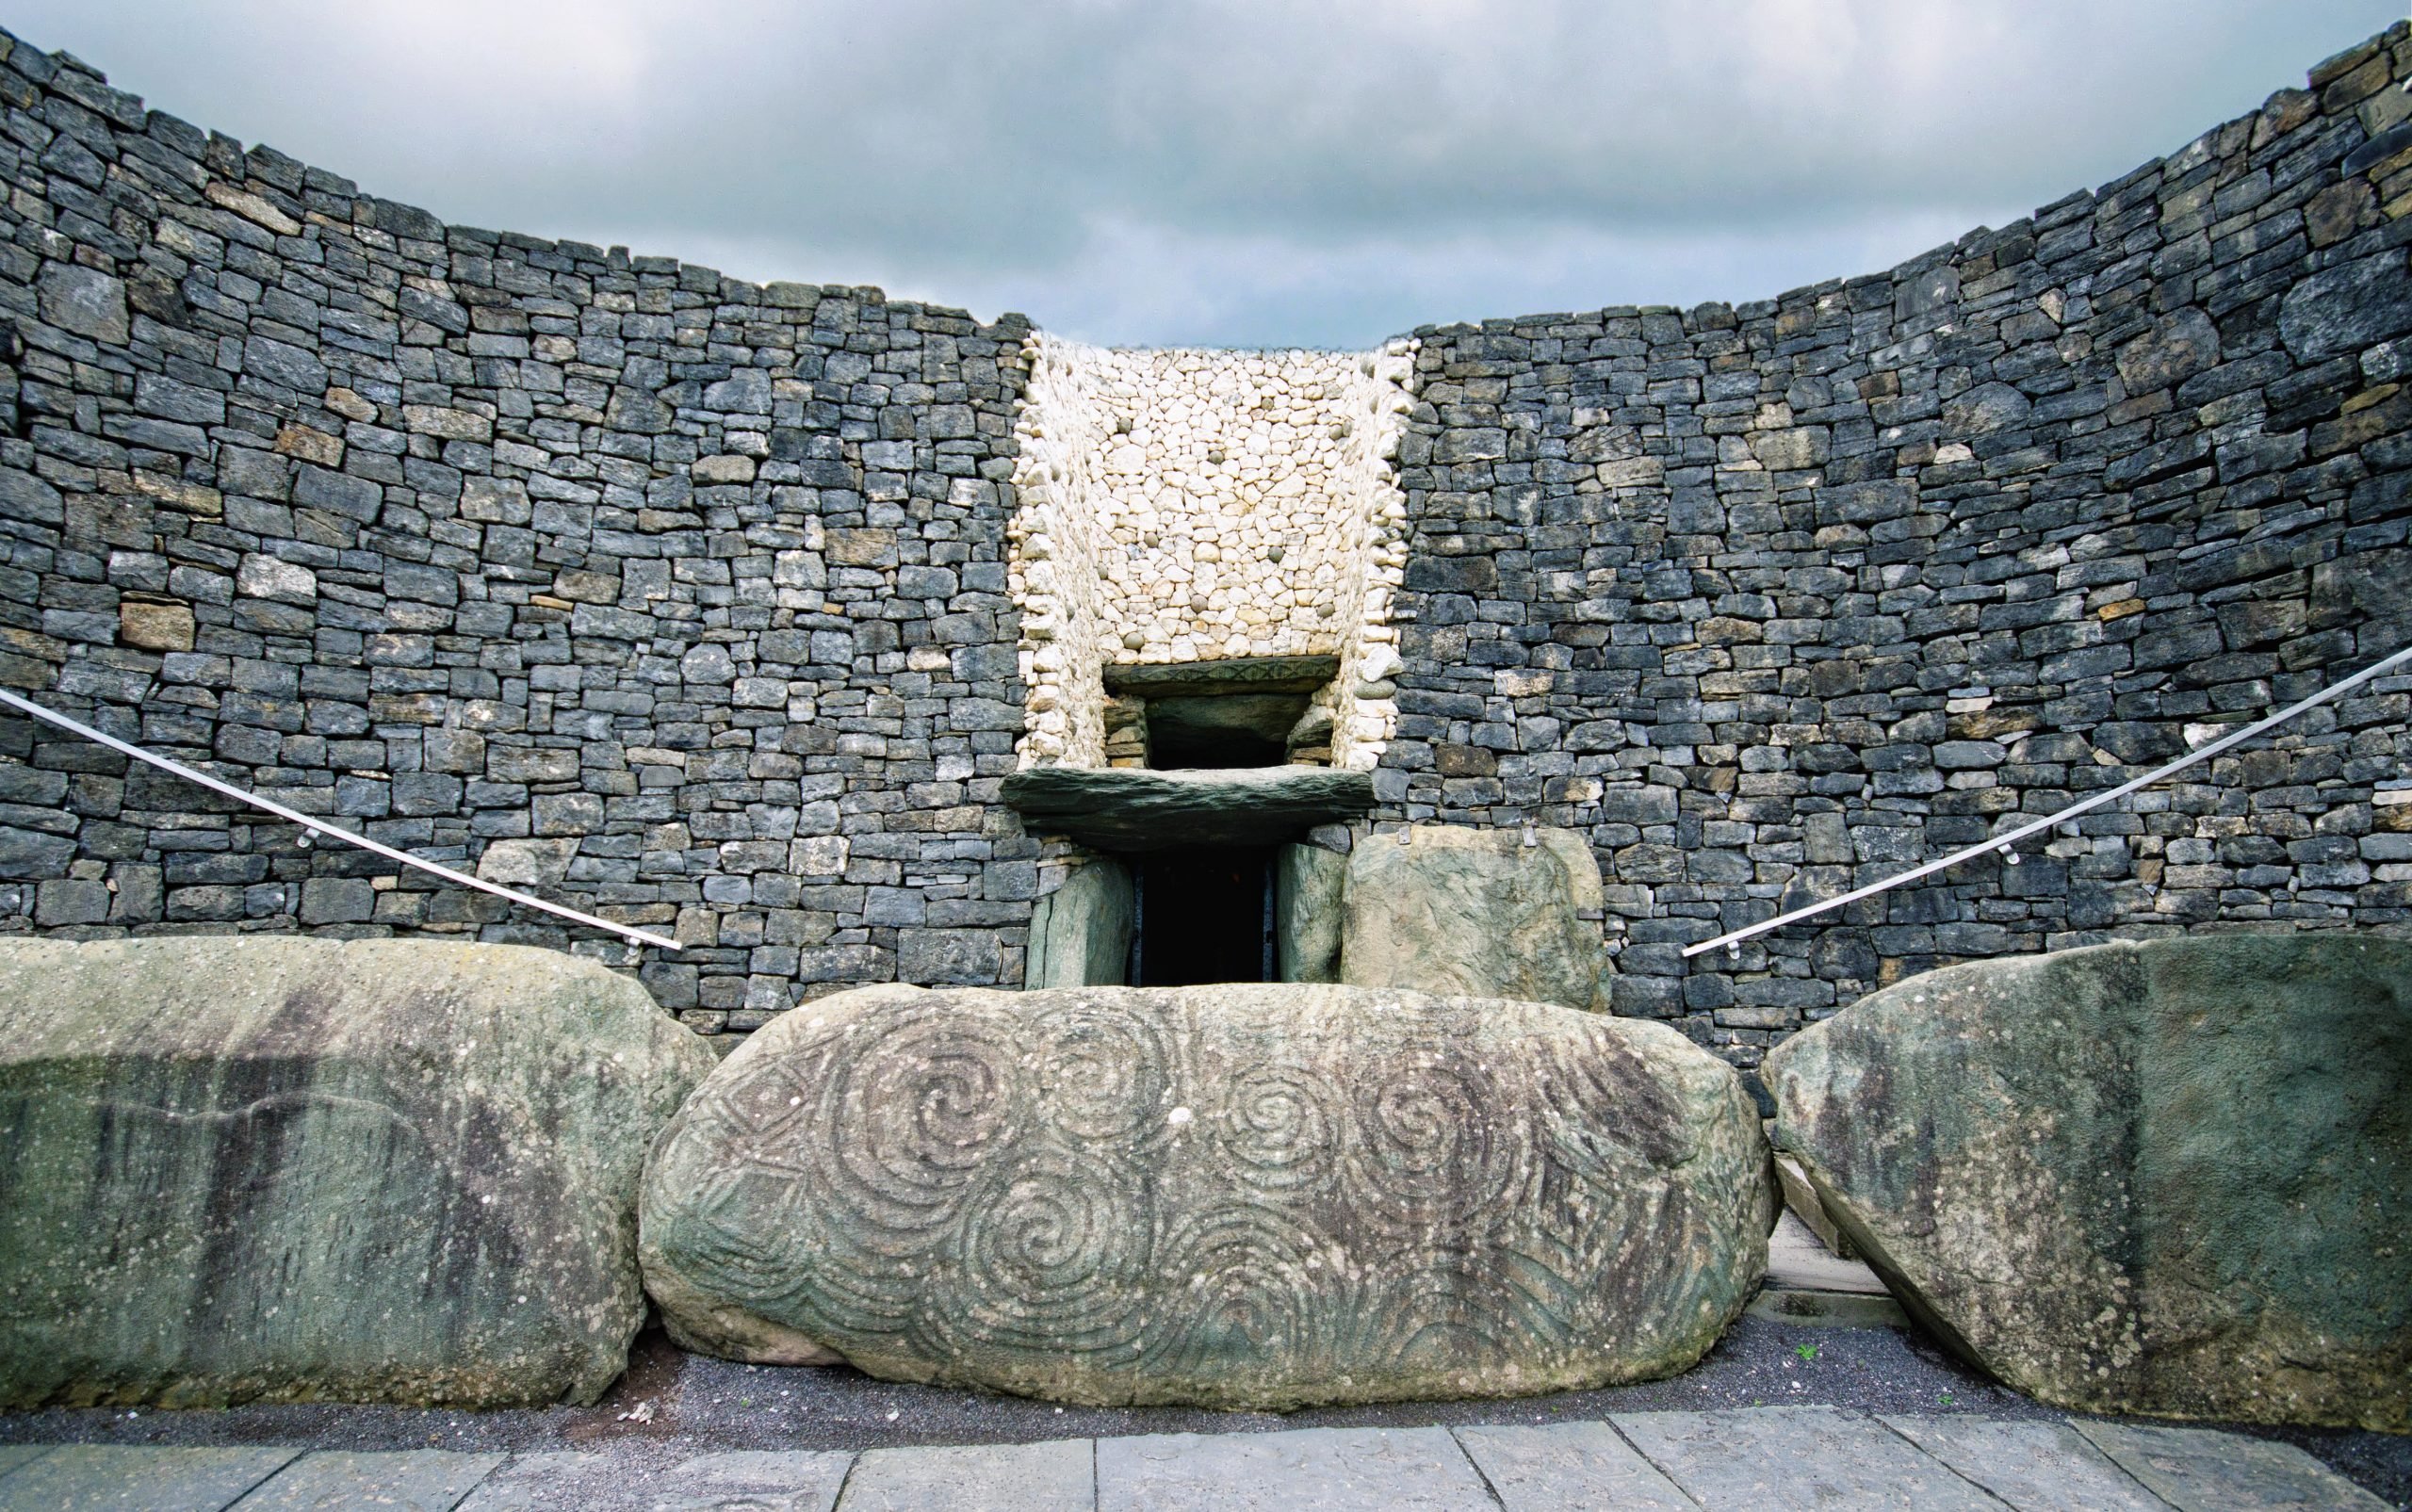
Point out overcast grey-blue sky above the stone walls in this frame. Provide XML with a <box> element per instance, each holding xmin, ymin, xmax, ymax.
<box><xmin>0</xmin><ymin>0</ymin><xmax>2407</xmax><ymax>348</ymax></box>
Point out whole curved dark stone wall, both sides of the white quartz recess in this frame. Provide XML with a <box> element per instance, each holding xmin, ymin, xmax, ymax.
<box><xmin>0</xmin><ymin>26</ymin><xmax>2412</xmax><ymax>1065</ymax></box>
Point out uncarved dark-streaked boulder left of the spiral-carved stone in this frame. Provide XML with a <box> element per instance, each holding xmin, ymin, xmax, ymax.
<box><xmin>0</xmin><ymin>938</ymin><xmax>714</xmax><ymax>1408</ymax></box>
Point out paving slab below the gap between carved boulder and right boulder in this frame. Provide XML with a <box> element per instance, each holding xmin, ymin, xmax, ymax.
<box><xmin>1609</xmin><ymin>1406</ymin><xmax>2002</xmax><ymax>1512</ymax></box>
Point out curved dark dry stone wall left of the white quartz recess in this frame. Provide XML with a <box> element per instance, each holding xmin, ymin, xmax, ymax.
<box><xmin>0</xmin><ymin>39</ymin><xmax>1037</xmax><ymax>1030</ymax></box>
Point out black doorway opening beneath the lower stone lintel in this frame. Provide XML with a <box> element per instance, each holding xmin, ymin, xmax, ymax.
<box><xmin>1129</xmin><ymin>849</ymin><xmax>1276</xmax><ymax>986</ymax></box>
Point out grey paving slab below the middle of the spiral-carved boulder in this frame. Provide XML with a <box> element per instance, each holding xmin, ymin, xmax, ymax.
<box><xmin>1098</xmin><ymin>1427</ymin><xmax>1491</xmax><ymax>1512</ymax></box>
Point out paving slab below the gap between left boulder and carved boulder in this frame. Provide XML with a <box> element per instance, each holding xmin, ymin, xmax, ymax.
<box><xmin>458</xmin><ymin>1449</ymin><xmax>854</xmax><ymax>1512</ymax></box>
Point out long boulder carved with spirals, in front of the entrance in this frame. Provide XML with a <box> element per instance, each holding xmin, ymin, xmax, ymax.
<box><xmin>642</xmin><ymin>984</ymin><xmax>1773</xmax><ymax>1410</ymax></box>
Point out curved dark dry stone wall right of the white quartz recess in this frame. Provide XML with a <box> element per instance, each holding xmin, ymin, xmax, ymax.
<box><xmin>1377</xmin><ymin>26</ymin><xmax>2412</xmax><ymax>1099</ymax></box>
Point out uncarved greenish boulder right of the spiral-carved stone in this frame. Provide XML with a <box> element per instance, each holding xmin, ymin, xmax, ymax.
<box><xmin>1766</xmin><ymin>934</ymin><xmax>2412</xmax><ymax>1433</ymax></box>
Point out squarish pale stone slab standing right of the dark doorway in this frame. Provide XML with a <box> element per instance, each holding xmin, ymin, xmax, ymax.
<box><xmin>1341</xmin><ymin>824</ymin><xmax>1609</xmax><ymax>1013</ymax></box>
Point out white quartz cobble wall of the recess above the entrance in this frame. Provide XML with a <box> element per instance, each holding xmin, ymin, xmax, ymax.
<box><xmin>1013</xmin><ymin>335</ymin><xmax>1413</xmax><ymax>767</ymax></box>
